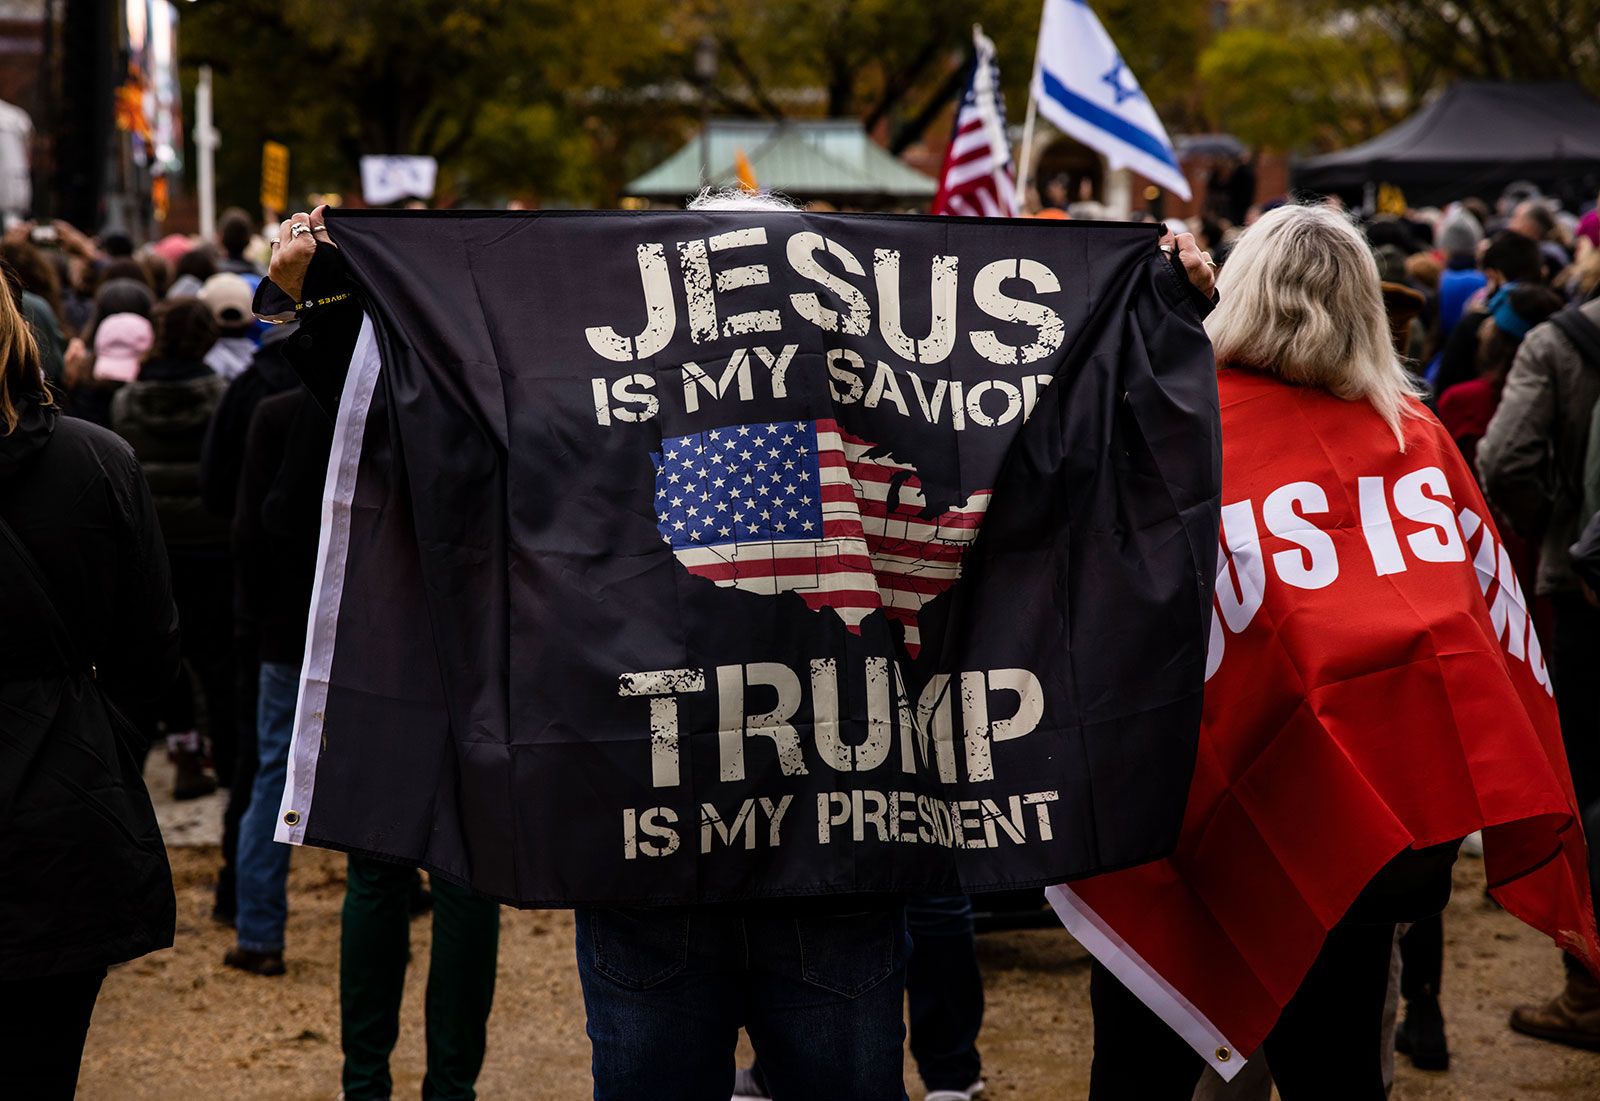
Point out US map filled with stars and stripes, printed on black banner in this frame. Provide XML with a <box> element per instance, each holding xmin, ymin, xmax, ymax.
<box><xmin>656</xmin><ymin>419</ymin><xmax>989</xmax><ymax>658</ymax></box>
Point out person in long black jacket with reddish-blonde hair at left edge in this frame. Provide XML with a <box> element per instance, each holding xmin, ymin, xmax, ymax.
<box><xmin>0</xmin><ymin>264</ymin><xmax>179</xmax><ymax>1101</ymax></box>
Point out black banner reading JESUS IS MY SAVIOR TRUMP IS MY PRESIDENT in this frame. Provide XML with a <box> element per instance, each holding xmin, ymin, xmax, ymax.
<box><xmin>278</xmin><ymin>211</ymin><xmax>1221</xmax><ymax>906</ymax></box>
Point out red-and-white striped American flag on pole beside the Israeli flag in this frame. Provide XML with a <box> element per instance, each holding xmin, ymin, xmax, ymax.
<box><xmin>933</xmin><ymin>26</ymin><xmax>1016</xmax><ymax>218</ymax></box>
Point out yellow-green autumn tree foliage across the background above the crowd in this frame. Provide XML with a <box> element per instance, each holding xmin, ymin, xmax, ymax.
<box><xmin>179</xmin><ymin>0</ymin><xmax>1600</xmax><ymax>205</ymax></box>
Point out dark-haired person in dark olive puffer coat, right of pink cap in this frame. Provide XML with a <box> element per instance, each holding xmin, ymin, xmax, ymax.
<box><xmin>110</xmin><ymin>298</ymin><xmax>235</xmax><ymax>799</ymax></box>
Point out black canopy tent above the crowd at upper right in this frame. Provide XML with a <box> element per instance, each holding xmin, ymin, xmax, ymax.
<box><xmin>1293</xmin><ymin>82</ymin><xmax>1600</xmax><ymax>197</ymax></box>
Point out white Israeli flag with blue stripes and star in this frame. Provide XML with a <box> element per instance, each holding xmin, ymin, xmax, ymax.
<box><xmin>1034</xmin><ymin>0</ymin><xmax>1189</xmax><ymax>198</ymax></box>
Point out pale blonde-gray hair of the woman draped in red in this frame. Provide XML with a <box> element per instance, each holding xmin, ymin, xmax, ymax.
<box><xmin>1205</xmin><ymin>205</ymin><xmax>1418</xmax><ymax>451</ymax></box>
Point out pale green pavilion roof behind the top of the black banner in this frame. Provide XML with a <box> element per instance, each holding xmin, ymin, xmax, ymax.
<box><xmin>622</xmin><ymin>118</ymin><xmax>938</xmax><ymax>208</ymax></box>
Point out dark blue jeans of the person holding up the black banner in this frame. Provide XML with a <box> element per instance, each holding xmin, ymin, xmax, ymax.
<box><xmin>576</xmin><ymin>901</ymin><xmax>906</xmax><ymax>1101</ymax></box>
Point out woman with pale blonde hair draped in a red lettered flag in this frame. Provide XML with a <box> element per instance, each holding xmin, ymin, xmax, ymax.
<box><xmin>1056</xmin><ymin>206</ymin><xmax>1595</xmax><ymax>1101</ymax></box>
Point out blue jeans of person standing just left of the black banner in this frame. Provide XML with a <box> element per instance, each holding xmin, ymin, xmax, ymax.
<box><xmin>235</xmin><ymin>661</ymin><xmax>299</xmax><ymax>952</ymax></box>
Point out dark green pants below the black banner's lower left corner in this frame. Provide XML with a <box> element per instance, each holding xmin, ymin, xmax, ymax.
<box><xmin>339</xmin><ymin>856</ymin><xmax>499</xmax><ymax>1101</ymax></box>
